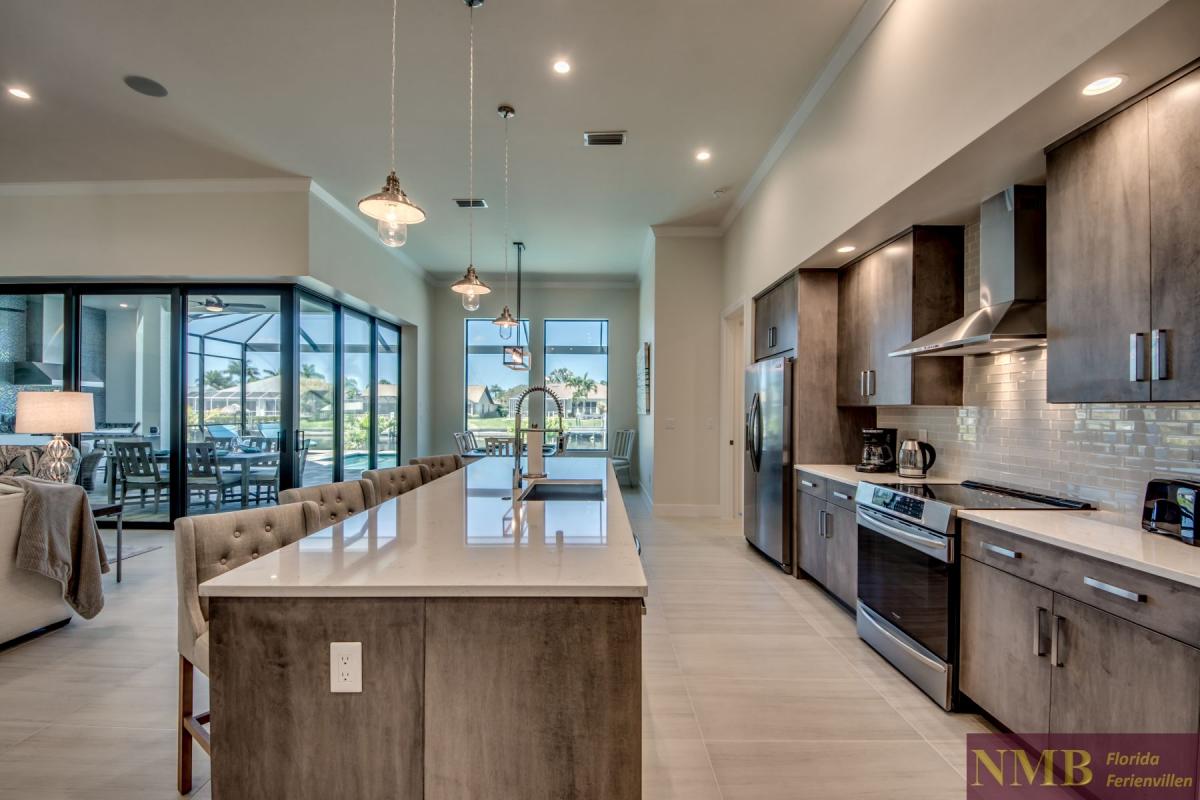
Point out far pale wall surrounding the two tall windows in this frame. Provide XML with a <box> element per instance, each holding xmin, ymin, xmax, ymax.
<box><xmin>430</xmin><ymin>283</ymin><xmax>638</xmax><ymax>470</ymax></box>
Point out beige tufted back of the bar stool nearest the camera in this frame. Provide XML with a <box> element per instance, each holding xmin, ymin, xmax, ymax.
<box><xmin>175</xmin><ymin>503</ymin><xmax>324</xmax><ymax>674</ymax></box>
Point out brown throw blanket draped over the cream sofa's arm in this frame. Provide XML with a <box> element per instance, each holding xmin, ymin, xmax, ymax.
<box><xmin>0</xmin><ymin>476</ymin><xmax>108</xmax><ymax>619</ymax></box>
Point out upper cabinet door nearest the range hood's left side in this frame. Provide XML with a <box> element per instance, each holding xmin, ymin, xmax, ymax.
<box><xmin>866</xmin><ymin>234</ymin><xmax>913</xmax><ymax>405</ymax></box>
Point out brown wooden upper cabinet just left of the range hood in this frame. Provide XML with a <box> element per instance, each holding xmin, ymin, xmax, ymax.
<box><xmin>838</xmin><ymin>225</ymin><xmax>962</xmax><ymax>405</ymax></box>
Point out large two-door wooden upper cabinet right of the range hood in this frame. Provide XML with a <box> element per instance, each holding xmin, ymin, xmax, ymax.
<box><xmin>1046</xmin><ymin>62</ymin><xmax>1200</xmax><ymax>403</ymax></box>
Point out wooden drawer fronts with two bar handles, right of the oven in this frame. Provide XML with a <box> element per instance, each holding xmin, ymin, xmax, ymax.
<box><xmin>961</xmin><ymin>519</ymin><xmax>1200</xmax><ymax>646</ymax></box>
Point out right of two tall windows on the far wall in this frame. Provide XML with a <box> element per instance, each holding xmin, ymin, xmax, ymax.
<box><xmin>542</xmin><ymin>319</ymin><xmax>608</xmax><ymax>450</ymax></box>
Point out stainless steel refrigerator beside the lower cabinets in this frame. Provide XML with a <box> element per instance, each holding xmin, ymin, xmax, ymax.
<box><xmin>742</xmin><ymin>356</ymin><xmax>792</xmax><ymax>570</ymax></box>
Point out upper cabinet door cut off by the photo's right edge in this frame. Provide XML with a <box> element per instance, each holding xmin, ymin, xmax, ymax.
<box><xmin>1147</xmin><ymin>71</ymin><xmax>1200</xmax><ymax>402</ymax></box>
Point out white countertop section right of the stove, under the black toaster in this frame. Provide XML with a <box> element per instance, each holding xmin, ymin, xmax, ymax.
<box><xmin>959</xmin><ymin>510</ymin><xmax>1200</xmax><ymax>587</ymax></box>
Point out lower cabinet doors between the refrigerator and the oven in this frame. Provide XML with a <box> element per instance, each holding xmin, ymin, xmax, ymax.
<box><xmin>797</xmin><ymin>492</ymin><xmax>858</xmax><ymax>608</ymax></box>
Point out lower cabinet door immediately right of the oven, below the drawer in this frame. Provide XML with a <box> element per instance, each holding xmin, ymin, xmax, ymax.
<box><xmin>959</xmin><ymin>558</ymin><xmax>1054</xmax><ymax>734</ymax></box>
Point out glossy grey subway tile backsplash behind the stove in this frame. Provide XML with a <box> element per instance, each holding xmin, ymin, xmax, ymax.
<box><xmin>878</xmin><ymin>219</ymin><xmax>1200</xmax><ymax>522</ymax></box>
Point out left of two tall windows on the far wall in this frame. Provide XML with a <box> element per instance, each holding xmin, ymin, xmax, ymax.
<box><xmin>464</xmin><ymin>319</ymin><xmax>529</xmax><ymax>446</ymax></box>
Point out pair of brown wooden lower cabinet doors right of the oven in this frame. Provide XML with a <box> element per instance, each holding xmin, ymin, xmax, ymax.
<box><xmin>959</xmin><ymin>558</ymin><xmax>1200</xmax><ymax>734</ymax></box>
